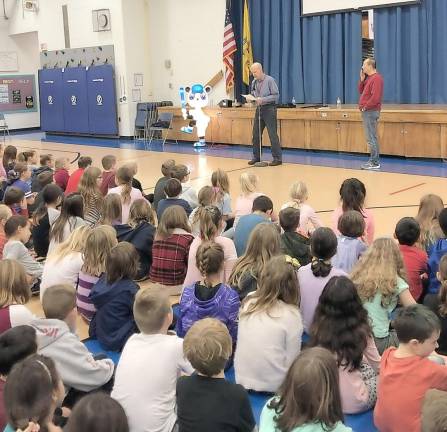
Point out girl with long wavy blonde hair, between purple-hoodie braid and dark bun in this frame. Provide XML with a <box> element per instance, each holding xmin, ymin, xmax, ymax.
<box><xmin>228</xmin><ymin>223</ymin><xmax>281</xmax><ymax>300</ymax></box>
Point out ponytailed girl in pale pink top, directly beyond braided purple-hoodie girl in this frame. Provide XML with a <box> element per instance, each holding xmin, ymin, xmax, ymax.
<box><xmin>184</xmin><ymin>205</ymin><xmax>237</xmax><ymax>286</ymax></box>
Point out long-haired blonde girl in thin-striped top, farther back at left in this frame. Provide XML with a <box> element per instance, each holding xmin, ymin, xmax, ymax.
<box><xmin>78</xmin><ymin>166</ymin><xmax>104</xmax><ymax>227</ymax></box>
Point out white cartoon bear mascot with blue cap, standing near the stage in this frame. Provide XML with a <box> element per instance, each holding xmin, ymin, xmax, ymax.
<box><xmin>180</xmin><ymin>84</ymin><xmax>211</xmax><ymax>147</ymax></box>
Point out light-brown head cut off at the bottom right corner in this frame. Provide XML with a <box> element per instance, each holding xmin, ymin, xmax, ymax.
<box><xmin>421</xmin><ymin>390</ymin><xmax>447</xmax><ymax>432</ymax></box>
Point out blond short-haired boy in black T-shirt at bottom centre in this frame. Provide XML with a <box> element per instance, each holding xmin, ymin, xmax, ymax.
<box><xmin>177</xmin><ymin>318</ymin><xmax>256</xmax><ymax>432</ymax></box>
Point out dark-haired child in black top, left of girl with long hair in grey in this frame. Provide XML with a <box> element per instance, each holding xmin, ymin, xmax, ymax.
<box><xmin>31</xmin><ymin>184</ymin><xmax>64</xmax><ymax>258</ymax></box>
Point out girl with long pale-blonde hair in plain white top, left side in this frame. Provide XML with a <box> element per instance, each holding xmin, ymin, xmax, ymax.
<box><xmin>40</xmin><ymin>225</ymin><xmax>90</xmax><ymax>300</ymax></box>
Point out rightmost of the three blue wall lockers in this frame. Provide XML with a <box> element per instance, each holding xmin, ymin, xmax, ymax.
<box><xmin>87</xmin><ymin>65</ymin><xmax>118</xmax><ymax>135</ymax></box>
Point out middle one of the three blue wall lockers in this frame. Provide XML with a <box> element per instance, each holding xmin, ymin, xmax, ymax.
<box><xmin>62</xmin><ymin>67</ymin><xmax>90</xmax><ymax>133</ymax></box>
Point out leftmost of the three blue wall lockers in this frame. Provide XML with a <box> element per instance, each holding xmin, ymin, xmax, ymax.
<box><xmin>39</xmin><ymin>69</ymin><xmax>64</xmax><ymax>132</ymax></box>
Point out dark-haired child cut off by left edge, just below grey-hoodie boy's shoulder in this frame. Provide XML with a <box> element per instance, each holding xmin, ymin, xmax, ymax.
<box><xmin>0</xmin><ymin>325</ymin><xmax>37</xmax><ymax>430</ymax></box>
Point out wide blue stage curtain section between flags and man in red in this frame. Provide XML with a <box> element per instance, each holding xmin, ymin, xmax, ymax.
<box><xmin>233</xmin><ymin>0</ymin><xmax>362</xmax><ymax>103</ymax></box>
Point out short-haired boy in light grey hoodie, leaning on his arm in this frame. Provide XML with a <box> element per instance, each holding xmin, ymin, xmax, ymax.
<box><xmin>31</xmin><ymin>285</ymin><xmax>115</xmax><ymax>392</ymax></box>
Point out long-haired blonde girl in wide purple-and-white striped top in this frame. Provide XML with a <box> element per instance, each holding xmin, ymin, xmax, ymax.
<box><xmin>76</xmin><ymin>225</ymin><xmax>118</xmax><ymax>322</ymax></box>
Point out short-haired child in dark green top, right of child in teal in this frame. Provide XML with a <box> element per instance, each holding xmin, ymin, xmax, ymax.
<box><xmin>279</xmin><ymin>207</ymin><xmax>312</xmax><ymax>266</ymax></box>
